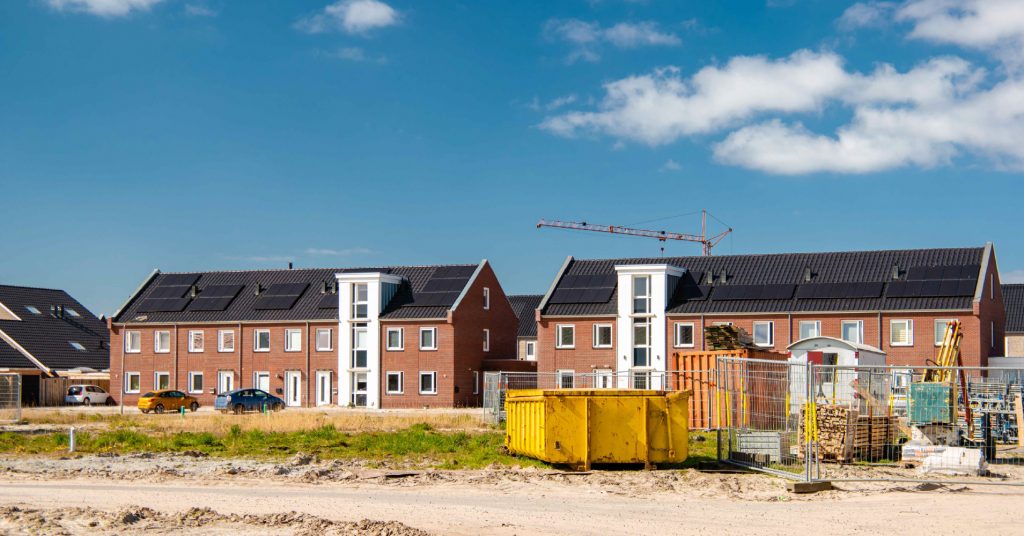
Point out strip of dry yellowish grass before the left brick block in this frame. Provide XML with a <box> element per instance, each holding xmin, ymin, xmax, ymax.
<box><xmin>23</xmin><ymin>409</ymin><xmax>494</xmax><ymax>434</ymax></box>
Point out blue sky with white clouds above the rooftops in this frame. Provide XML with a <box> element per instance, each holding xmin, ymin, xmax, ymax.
<box><xmin>0</xmin><ymin>0</ymin><xmax>1024</xmax><ymax>315</ymax></box>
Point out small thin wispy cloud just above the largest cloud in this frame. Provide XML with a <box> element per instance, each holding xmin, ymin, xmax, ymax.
<box><xmin>544</xmin><ymin>18</ymin><xmax>682</xmax><ymax>63</ymax></box>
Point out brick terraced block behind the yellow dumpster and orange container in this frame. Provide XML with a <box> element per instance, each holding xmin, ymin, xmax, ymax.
<box><xmin>537</xmin><ymin>244</ymin><xmax>1006</xmax><ymax>387</ymax></box>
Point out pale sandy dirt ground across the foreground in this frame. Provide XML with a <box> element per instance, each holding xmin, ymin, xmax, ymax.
<box><xmin>0</xmin><ymin>455</ymin><xmax>1024</xmax><ymax>536</ymax></box>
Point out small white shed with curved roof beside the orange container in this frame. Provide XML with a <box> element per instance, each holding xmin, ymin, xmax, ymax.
<box><xmin>787</xmin><ymin>337</ymin><xmax>892</xmax><ymax>406</ymax></box>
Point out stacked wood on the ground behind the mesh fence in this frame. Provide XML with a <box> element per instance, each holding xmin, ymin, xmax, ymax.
<box><xmin>798</xmin><ymin>404</ymin><xmax>898</xmax><ymax>462</ymax></box>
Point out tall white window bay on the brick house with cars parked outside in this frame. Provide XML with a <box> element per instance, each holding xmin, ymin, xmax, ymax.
<box><xmin>335</xmin><ymin>272</ymin><xmax>402</xmax><ymax>408</ymax></box>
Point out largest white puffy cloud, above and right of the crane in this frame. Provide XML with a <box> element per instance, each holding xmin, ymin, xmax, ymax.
<box><xmin>541</xmin><ymin>50</ymin><xmax>1024</xmax><ymax>174</ymax></box>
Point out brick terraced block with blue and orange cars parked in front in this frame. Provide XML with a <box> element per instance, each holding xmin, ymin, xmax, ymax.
<box><xmin>109</xmin><ymin>260</ymin><xmax>516</xmax><ymax>408</ymax></box>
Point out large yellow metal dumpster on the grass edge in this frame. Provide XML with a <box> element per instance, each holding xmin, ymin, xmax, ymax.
<box><xmin>505</xmin><ymin>389</ymin><xmax>690</xmax><ymax>470</ymax></box>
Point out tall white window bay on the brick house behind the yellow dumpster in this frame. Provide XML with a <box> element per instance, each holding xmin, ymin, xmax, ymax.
<box><xmin>615</xmin><ymin>264</ymin><xmax>686</xmax><ymax>389</ymax></box>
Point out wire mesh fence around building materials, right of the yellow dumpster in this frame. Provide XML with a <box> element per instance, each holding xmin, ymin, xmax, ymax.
<box><xmin>719</xmin><ymin>358</ymin><xmax>1024</xmax><ymax>485</ymax></box>
